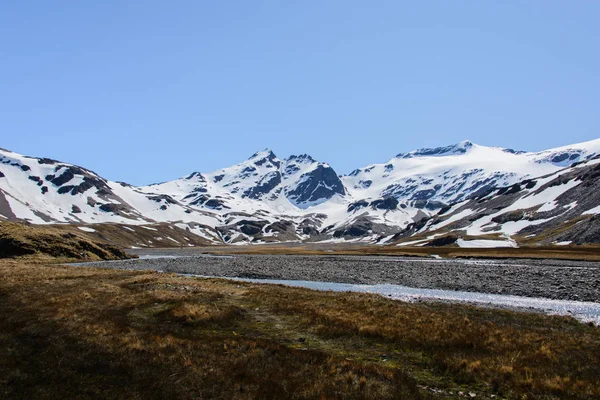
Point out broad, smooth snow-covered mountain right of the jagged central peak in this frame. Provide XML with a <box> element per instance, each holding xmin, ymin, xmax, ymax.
<box><xmin>344</xmin><ymin>141</ymin><xmax>600</xmax><ymax>206</ymax></box>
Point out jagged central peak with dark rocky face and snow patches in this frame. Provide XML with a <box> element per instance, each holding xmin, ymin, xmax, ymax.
<box><xmin>142</xmin><ymin>149</ymin><xmax>346</xmax><ymax>212</ymax></box>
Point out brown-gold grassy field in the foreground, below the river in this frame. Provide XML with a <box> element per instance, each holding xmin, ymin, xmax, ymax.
<box><xmin>0</xmin><ymin>260</ymin><xmax>600</xmax><ymax>399</ymax></box>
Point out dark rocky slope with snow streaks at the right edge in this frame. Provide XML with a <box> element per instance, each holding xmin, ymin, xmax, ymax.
<box><xmin>394</xmin><ymin>155</ymin><xmax>600</xmax><ymax>247</ymax></box>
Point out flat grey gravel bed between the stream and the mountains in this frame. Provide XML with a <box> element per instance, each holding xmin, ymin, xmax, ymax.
<box><xmin>71</xmin><ymin>250</ymin><xmax>600</xmax><ymax>302</ymax></box>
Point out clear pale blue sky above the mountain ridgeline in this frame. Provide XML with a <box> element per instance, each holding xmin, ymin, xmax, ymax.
<box><xmin>0</xmin><ymin>0</ymin><xmax>600</xmax><ymax>184</ymax></box>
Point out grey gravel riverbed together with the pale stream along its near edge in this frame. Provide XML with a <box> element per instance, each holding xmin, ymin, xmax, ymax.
<box><xmin>69</xmin><ymin>250</ymin><xmax>600</xmax><ymax>325</ymax></box>
